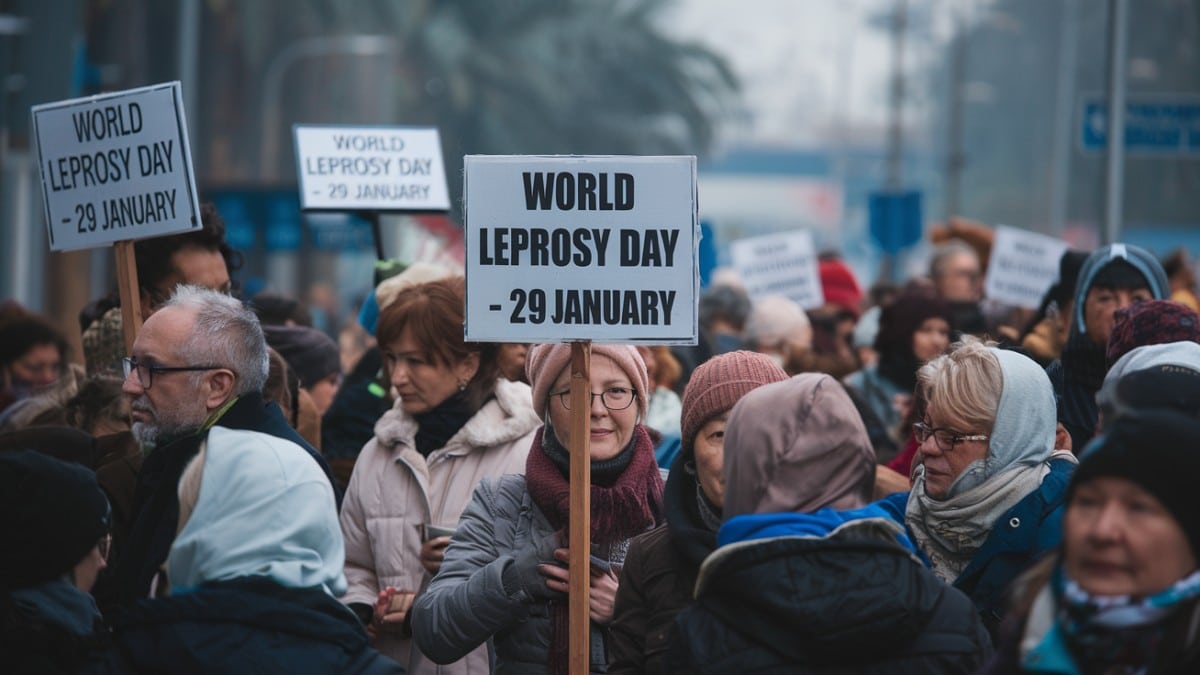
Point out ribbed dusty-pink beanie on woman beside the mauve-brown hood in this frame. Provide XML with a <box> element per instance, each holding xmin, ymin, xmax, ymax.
<box><xmin>680</xmin><ymin>351</ymin><xmax>787</xmax><ymax>456</ymax></box>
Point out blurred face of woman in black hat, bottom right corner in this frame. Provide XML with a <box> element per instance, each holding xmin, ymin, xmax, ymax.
<box><xmin>1063</xmin><ymin>477</ymin><xmax>1196</xmax><ymax>598</ymax></box>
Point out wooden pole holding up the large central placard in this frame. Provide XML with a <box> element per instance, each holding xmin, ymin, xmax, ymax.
<box><xmin>568</xmin><ymin>341</ymin><xmax>592</xmax><ymax>675</ymax></box>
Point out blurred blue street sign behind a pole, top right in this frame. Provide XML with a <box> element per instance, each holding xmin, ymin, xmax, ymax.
<box><xmin>1079</xmin><ymin>96</ymin><xmax>1200</xmax><ymax>156</ymax></box>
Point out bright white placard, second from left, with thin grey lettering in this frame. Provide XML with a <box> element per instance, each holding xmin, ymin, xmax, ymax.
<box><xmin>293</xmin><ymin>125</ymin><xmax>450</xmax><ymax>211</ymax></box>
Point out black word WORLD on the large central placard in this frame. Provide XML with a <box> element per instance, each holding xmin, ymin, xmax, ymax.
<box><xmin>521</xmin><ymin>171</ymin><xmax>634</xmax><ymax>211</ymax></box>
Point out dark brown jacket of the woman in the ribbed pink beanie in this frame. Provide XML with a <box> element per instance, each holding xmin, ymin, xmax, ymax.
<box><xmin>608</xmin><ymin>458</ymin><xmax>716</xmax><ymax>674</ymax></box>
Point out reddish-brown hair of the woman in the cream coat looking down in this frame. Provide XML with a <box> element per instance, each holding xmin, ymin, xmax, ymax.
<box><xmin>376</xmin><ymin>276</ymin><xmax>500</xmax><ymax>407</ymax></box>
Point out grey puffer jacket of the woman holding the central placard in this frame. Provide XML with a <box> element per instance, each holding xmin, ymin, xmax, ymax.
<box><xmin>412</xmin><ymin>476</ymin><xmax>607</xmax><ymax>675</ymax></box>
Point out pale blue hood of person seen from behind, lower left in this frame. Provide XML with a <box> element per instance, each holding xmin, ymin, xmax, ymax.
<box><xmin>167</xmin><ymin>426</ymin><xmax>347</xmax><ymax>595</ymax></box>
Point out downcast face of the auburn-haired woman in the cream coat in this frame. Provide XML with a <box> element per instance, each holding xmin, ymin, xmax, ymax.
<box><xmin>383</xmin><ymin>328</ymin><xmax>479</xmax><ymax>414</ymax></box>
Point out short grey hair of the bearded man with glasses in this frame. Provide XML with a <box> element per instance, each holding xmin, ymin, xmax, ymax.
<box><xmin>163</xmin><ymin>285</ymin><xmax>270</xmax><ymax>395</ymax></box>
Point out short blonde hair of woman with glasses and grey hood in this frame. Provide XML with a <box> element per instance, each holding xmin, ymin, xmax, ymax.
<box><xmin>917</xmin><ymin>335</ymin><xmax>1004</xmax><ymax>434</ymax></box>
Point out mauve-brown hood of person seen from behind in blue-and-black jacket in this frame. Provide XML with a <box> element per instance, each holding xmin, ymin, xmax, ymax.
<box><xmin>724</xmin><ymin>372</ymin><xmax>878</xmax><ymax>520</ymax></box>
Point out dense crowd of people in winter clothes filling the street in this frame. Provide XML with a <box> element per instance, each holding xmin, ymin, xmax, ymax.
<box><xmin>0</xmin><ymin>205</ymin><xmax>1200</xmax><ymax>675</ymax></box>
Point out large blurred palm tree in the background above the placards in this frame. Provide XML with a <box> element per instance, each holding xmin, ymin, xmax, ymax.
<box><xmin>232</xmin><ymin>0</ymin><xmax>738</xmax><ymax>211</ymax></box>
